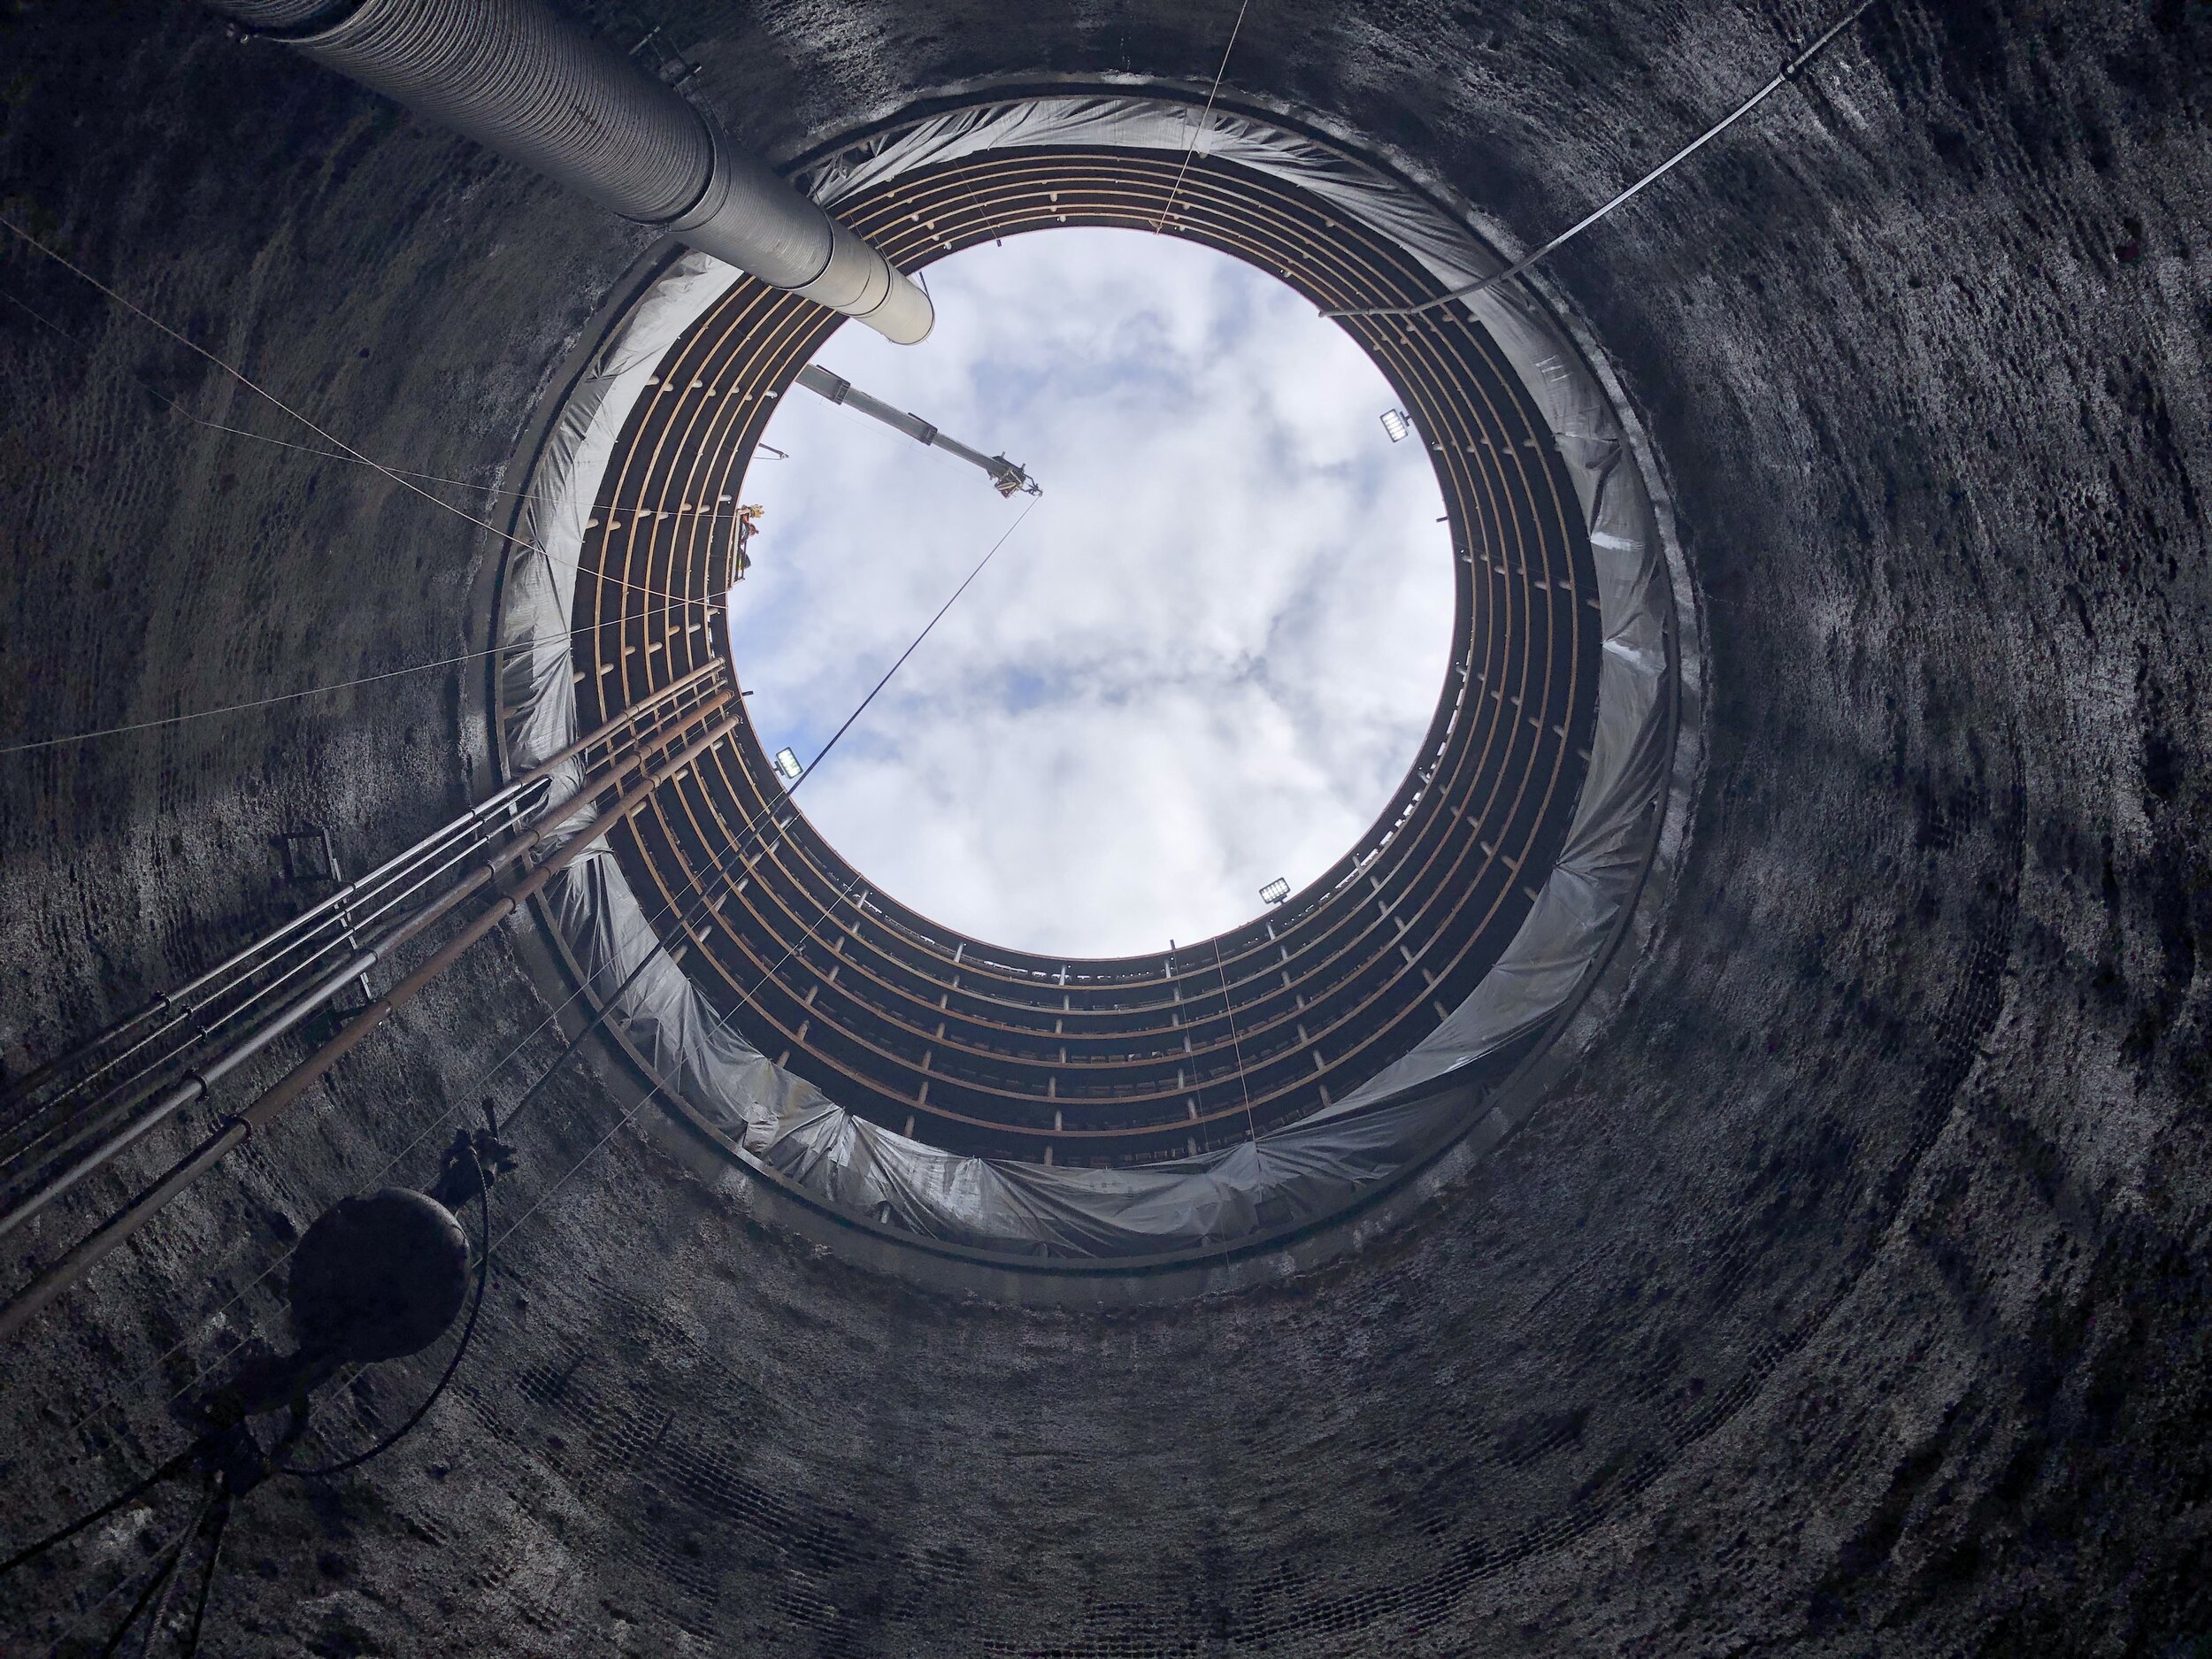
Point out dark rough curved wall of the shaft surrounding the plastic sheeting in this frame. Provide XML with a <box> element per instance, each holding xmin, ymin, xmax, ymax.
<box><xmin>0</xmin><ymin>0</ymin><xmax>2212</xmax><ymax>1659</ymax></box>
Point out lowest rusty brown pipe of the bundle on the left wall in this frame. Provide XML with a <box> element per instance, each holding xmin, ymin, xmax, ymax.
<box><xmin>0</xmin><ymin>715</ymin><xmax>741</xmax><ymax>1343</ymax></box>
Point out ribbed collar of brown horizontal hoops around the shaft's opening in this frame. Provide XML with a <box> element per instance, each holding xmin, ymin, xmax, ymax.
<box><xmin>557</xmin><ymin>136</ymin><xmax>1601</xmax><ymax>1166</ymax></box>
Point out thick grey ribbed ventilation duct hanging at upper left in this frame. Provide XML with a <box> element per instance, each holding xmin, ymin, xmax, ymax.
<box><xmin>208</xmin><ymin>0</ymin><xmax>936</xmax><ymax>345</ymax></box>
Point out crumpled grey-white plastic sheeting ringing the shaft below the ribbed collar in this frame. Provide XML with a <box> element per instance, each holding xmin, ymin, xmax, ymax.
<box><xmin>503</xmin><ymin>97</ymin><xmax>1675</xmax><ymax>1259</ymax></box>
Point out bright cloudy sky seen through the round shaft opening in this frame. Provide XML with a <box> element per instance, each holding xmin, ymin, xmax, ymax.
<box><xmin>730</xmin><ymin>228</ymin><xmax>1454</xmax><ymax>956</ymax></box>
